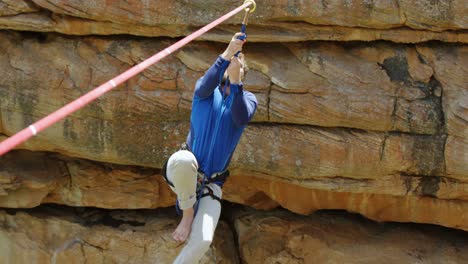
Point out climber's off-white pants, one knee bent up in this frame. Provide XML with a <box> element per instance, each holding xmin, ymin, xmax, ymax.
<box><xmin>167</xmin><ymin>150</ymin><xmax>222</xmax><ymax>264</ymax></box>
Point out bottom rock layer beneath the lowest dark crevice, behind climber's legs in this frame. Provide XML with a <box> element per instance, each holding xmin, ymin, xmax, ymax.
<box><xmin>0</xmin><ymin>206</ymin><xmax>468</xmax><ymax>264</ymax></box>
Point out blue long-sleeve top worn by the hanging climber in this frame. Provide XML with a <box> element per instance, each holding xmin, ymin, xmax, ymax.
<box><xmin>187</xmin><ymin>56</ymin><xmax>257</xmax><ymax>186</ymax></box>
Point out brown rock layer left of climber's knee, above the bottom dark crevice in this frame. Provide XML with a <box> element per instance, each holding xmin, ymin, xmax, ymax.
<box><xmin>0</xmin><ymin>151</ymin><xmax>175</xmax><ymax>209</ymax></box>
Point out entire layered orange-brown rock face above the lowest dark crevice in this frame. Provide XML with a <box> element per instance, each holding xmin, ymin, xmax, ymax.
<box><xmin>0</xmin><ymin>0</ymin><xmax>468</xmax><ymax>263</ymax></box>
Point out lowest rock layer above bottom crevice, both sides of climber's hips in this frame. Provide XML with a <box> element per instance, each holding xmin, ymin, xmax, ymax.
<box><xmin>0</xmin><ymin>151</ymin><xmax>468</xmax><ymax>230</ymax></box>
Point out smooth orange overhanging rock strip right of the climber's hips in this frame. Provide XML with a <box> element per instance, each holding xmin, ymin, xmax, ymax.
<box><xmin>225</xmin><ymin>176</ymin><xmax>468</xmax><ymax>231</ymax></box>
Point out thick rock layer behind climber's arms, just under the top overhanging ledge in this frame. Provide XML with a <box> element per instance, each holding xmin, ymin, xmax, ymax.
<box><xmin>0</xmin><ymin>32</ymin><xmax>460</xmax><ymax>134</ymax></box>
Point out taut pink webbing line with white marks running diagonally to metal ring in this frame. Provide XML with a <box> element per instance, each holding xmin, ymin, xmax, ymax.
<box><xmin>0</xmin><ymin>1</ymin><xmax>252</xmax><ymax>156</ymax></box>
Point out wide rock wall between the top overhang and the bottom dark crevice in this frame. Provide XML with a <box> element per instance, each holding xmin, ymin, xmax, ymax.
<box><xmin>0</xmin><ymin>24</ymin><xmax>468</xmax><ymax>230</ymax></box>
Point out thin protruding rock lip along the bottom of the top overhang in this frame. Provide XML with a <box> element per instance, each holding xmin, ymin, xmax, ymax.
<box><xmin>0</xmin><ymin>13</ymin><xmax>468</xmax><ymax>43</ymax></box>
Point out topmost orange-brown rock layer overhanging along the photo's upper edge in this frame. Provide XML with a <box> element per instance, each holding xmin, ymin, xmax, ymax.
<box><xmin>0</xmin><ymin>0</ymin><xmax>468</xmax><ymax>43</ymax></box>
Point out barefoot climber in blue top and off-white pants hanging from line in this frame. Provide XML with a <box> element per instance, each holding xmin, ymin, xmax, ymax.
<box><xmin>163</xmin><ymin>33</ymin><xmax>257</xmax><ymax>263</ymax></box>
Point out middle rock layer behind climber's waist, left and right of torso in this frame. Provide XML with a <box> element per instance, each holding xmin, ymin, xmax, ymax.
<box><xmin>0</xmin><ymin>118</ymin><xmax>450</xmax><ymax>181</ymax></box>
